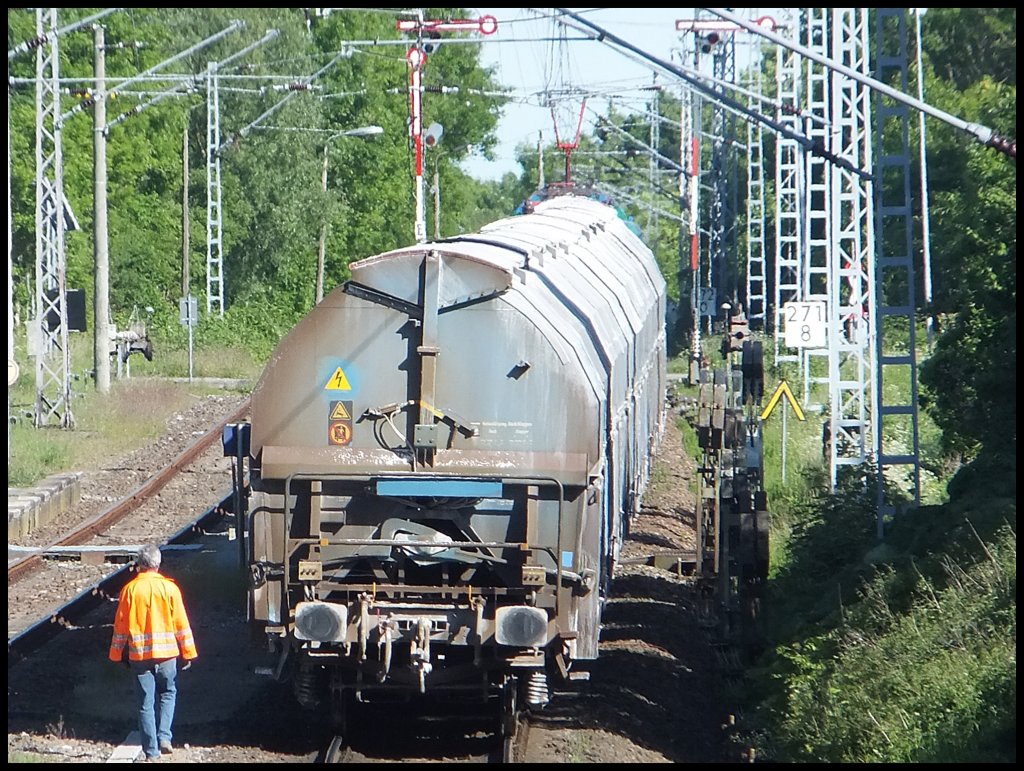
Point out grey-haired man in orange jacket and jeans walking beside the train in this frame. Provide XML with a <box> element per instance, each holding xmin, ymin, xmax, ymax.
<box><xmin>110</xmin><ymin>545</ymin><xmax>199</xmax><ymax>762</ymax></box>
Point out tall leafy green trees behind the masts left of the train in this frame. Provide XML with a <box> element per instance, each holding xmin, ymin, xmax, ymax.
<box><xmin>7</xmin><ymin>8</ymin><xmax>500</xmax><ymax>352</ymax></box>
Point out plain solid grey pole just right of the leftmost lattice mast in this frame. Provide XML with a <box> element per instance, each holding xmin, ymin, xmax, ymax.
<box><xmin>92</xmin><ymin>25</ymin><xmax>111</xmax><ymax>393</ymax></box>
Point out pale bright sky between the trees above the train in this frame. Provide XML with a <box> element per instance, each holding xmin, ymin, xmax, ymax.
<box><xmin>463</xmin><ymin>7</ymin><xmax>760</xmax><ymax>179</ymax></box>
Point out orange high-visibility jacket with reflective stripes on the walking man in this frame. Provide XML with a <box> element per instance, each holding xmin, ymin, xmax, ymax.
<box><xmin>110</xmin><ymin>570</ymin><xmax>199</xmax><ymax>661</ymax></box>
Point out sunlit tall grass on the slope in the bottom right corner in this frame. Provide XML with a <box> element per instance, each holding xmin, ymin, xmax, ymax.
<box><xmin>766</xmin><ymin>526</ymin><xmax>1017</xmax><ymax>763</ymax></box>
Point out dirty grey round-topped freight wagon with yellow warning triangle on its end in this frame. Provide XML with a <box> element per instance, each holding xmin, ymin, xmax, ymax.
<box><xmin>228</xmin><ymin>195</ymin><xmax>666</xmax><ymax>720</ymax></box>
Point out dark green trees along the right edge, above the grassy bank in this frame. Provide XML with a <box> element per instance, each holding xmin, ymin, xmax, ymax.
<box><xmin>922</xmin><ymin>8</ymin><xmax>1017</xmax><ymax>459</ymax></box>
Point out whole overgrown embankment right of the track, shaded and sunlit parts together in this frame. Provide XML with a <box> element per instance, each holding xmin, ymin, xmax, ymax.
<box><xmin>743</xmin><ymin>321</ymin><xmax>1016</xmax><ymax>763</ymax></box>
